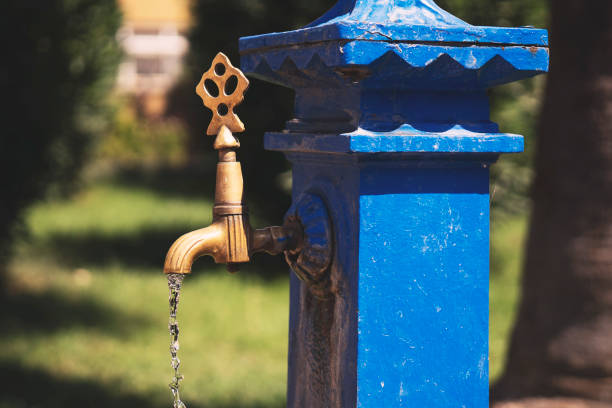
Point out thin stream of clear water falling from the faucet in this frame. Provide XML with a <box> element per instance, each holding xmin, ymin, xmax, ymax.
<box><xmin>168</xmin><ymin>273</ymin><xmax>187</xmax><ymax>408</ymax></box>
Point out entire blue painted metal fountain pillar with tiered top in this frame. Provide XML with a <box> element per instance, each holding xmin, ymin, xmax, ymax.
<box><xmin>240</xmin><ymin>0</ymin><xmax>548</xmax><ymax>408</ymax></box>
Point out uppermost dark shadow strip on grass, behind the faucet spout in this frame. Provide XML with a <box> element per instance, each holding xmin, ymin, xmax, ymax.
<box><xmin>29</xmin><ymin>227</ymin><xmax>288</xmax><ymax>279</ymax></box>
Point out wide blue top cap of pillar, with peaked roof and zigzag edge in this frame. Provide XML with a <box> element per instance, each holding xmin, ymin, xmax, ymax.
<box><xmin>240</xmin><ymin>0</ymin><xmax>548</xmax><ymax>89</ymax></box>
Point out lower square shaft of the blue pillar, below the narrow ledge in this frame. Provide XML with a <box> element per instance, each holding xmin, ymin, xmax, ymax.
<box><xmin>288</xmin><ymin>152</ymin><xmax>497</xmax><ymax>408</ymax></box>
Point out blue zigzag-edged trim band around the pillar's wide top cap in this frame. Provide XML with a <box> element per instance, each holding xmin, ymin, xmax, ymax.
<box><xmin>241</xmin><ymin>41</ymin><xmax>549</xmax><ymax>87</ymax></box>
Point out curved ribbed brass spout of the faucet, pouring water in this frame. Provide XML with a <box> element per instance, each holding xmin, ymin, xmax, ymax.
<box><xmin>164</xmin><ymin>219</ymin><xmax>226</xmax><ymax>274</ymax></box>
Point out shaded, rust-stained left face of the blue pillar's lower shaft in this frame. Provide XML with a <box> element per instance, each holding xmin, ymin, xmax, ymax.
<box><xmin>287</xmin><ymin>153</ymin><xmax>359</xmax><ymax>408</ymax></box>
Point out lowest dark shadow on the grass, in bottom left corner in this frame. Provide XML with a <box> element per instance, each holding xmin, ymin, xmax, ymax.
<box><xmin>0</xmin><ymin>361</ymin><xmax>284</xmax><ymax>408</ymax></box>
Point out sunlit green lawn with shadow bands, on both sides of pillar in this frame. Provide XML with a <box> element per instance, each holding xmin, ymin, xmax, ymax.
<box><xmin>0</xmin><ymin>179</ymin><xmax>525</xmax><ymax>408</ymax></box>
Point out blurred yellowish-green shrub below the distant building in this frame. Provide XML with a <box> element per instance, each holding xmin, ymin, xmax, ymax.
<box><xmin>96</xmin><ymin>100</ymin><xmax>187</xmax><ymax>167</ymax></box>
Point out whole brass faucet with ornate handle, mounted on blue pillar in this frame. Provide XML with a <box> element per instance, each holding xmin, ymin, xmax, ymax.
<box><xmin>164</xmin><ymin>53</ymin><xmax>306</xmax><ymax>274</ymax></box>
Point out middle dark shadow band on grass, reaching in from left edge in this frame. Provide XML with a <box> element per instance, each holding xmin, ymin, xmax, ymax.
<box><xmin>0</xmin><ymin>292</ymin><xmax>152</xmax><ymax>338</ymax></box>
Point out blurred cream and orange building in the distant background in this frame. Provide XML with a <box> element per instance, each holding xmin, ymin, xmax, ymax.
<box><xmin>117</xmin><ymin>0</ymin><xmax>190</xmax><ymax>117</ymax></box>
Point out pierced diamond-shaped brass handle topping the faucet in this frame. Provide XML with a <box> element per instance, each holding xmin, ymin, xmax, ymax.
<box><xmin>196</xmin><ymin>52</ymin><xmax>249</xmax><ymax>136</ymax></box>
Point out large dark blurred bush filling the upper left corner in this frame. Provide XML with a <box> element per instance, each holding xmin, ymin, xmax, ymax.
<box><xmin>0</xmin><ymin>0</ymin><xmax>121</xmax><ymax>268</ymax></box>
